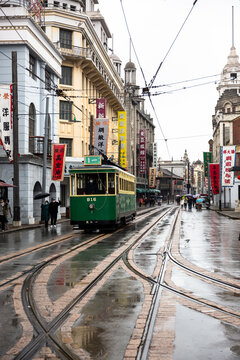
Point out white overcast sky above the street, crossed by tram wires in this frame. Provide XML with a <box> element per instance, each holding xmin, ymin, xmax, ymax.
<box><xmin>96</xmin><ymin>0</ymin><xmax>240</xmax><ymax>161</ymax></box>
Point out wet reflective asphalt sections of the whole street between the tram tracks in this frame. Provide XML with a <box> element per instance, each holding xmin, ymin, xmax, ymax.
<box><xmin>0</xmin><ymin>209</ymin><xmax>240</xmax><ymax>360</ymax></box>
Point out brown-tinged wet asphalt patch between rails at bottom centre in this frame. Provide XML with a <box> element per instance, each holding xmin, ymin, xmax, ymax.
<box><xmin>59</xmin><ymin>268</ymin><xmax>144</xmax><ymax>360</ymax></box>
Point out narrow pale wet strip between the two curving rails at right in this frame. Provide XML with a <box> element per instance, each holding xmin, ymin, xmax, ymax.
<box><xmin>172</xmin><ymin>267</ymin><xmax>240</xmax><ymax>311</ymax></box>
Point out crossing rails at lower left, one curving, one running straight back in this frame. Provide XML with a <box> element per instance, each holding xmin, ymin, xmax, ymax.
<box><xmin>11</xmin><ymin>208</ymin><xmax>171</xmax><ymax>359</ymax></box>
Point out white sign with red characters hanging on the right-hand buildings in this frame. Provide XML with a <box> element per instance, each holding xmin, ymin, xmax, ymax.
<box><xmin>222</xmin><ymin>146</ymin><xmax>236</xmax><ymax>186</ymax></box>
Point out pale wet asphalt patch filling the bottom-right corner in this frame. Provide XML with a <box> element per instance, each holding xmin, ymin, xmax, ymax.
<box><xmin>173</xmin><ymin>304</ymin><xmax>240</xmax><ymax>360</ymax></box>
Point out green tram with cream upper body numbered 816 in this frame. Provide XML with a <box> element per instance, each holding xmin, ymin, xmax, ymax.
<box><xmin>69</xmin><ymin>165</ymin><xmax>136</xmax><ymax>230</ymax></box>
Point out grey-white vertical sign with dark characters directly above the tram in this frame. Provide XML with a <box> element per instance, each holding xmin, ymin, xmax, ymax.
<box><xmin>94</xmin><ymin>119</ymin><xmax>108</xmax><ymax>155</ymax></box>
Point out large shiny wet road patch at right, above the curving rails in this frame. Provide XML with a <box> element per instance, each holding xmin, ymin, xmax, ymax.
<box><xmin>180</xmin><ymin>209</ymin><xmax>240</xmax><ymax>280</ymax></box>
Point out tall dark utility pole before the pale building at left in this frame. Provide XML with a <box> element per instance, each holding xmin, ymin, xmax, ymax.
<box><xmin>12</xmin><ymin>51</ymin><xmax>21</xmax><ymax>226</ymax></box>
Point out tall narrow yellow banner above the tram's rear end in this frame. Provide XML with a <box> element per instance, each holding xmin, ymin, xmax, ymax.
<box><xmin>118</xmin><ymin>111</ymin><xmax>127</xmax><ymax>168</ymax></box>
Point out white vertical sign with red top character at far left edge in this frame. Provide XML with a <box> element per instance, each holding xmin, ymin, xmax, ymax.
<box><xmin>0</xmin><ymin>84</ymin><xmax>13</xmax><ymax>161</ymax></box>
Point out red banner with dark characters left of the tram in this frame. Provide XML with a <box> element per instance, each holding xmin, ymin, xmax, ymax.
<box><xmin>52</xmin><ymin>144</ymin><xmax>67</xmax><ymax>181</ymax></box>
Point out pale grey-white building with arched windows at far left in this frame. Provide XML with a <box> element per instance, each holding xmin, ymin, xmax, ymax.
<box><xmin>0</xmin><ymin>0</ymin><xmax>62</xmax><ymax>224</ymax></box>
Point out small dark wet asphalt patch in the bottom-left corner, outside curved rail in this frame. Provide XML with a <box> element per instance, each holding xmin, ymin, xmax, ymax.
<box><xmin>0</xmin><ymin>287</ymin><xmax>22</xmax><ymax>357</ymax></box>
